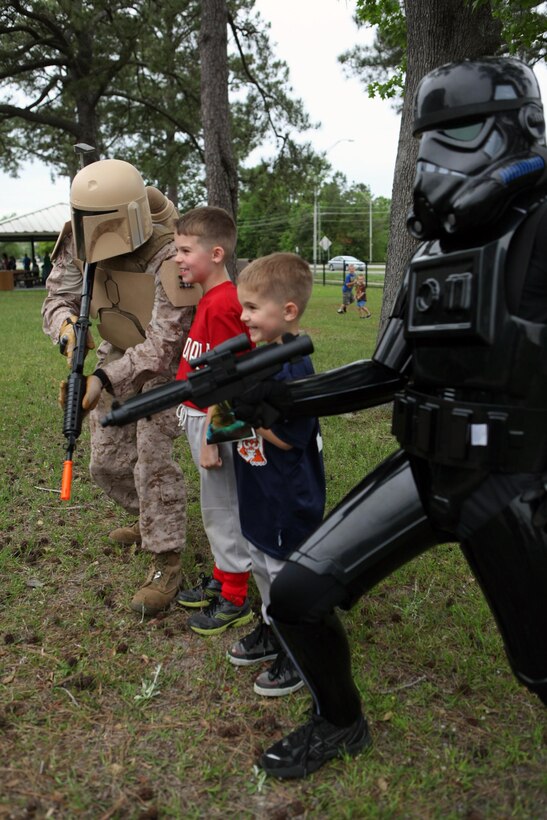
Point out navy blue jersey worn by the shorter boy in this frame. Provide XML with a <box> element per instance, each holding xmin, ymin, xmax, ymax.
<box><xmin>234</xmin><ymin>356</ymin><xmax>325</xmax><ymax>559</ymax></box>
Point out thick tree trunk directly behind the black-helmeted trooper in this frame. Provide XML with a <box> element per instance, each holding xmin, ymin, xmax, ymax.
<box><xmin>380</xmin><ymin>0</ymin><xmax>501</xmax><ymax>332</ymax></box>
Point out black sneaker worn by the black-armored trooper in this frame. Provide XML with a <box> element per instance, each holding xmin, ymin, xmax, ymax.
<box><xmin>260</xmin><ymin>715</ymin><xmax>372</xmax><ymax>778</ymax></box>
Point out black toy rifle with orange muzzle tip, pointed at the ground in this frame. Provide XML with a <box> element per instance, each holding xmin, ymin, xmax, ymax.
<box><xmin>59</xmin><ymin>143</ymin><xmax>96</xmax><ymax>501</ymax></box>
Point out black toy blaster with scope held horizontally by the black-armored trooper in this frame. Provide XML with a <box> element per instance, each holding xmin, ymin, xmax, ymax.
<box><xmin>101</xmin><ymin>333</ymin><xmax>313</xmax><ymax>427</ymax></box>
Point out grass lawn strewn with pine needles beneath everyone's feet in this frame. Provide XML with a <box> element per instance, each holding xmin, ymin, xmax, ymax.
<box><xmin>0</xmin><ymin>286</ymin><xmax>547</xmax><ymax>820</ymax></box>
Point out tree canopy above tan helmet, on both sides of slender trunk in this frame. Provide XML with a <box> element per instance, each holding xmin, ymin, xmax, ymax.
<box><xmin>0</xmin><ymin>0</ymin><xmax>309</xmax><ymax>201</ymax></box>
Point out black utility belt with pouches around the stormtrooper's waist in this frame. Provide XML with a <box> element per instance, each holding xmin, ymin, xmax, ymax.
<box><xmin>392</xmin><ymin>390</ymin><xmax>547</xmax><ymax>473</ymax></box>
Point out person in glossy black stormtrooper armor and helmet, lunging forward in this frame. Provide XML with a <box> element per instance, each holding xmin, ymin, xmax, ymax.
<box><xmin>261</xmin><ymin>58</ymin><xmax>547</xmax><ymax>777</ymax></box>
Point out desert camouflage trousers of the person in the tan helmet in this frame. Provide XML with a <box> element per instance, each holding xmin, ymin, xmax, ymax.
<box><xmin>89</xmin><ymin>390</ymin><xmax>186</xmax><ymax>553</ymax></box>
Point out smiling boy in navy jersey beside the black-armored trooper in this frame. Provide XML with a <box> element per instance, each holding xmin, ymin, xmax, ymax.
<box><xmin>228</xmin><ymin>253</ymin><xmax>325</xmax><ymax>696</ymax></box>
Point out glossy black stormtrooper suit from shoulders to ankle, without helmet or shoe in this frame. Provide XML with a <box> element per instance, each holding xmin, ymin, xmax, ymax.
<box><xmin>271</xmin><ymin>194</ymin><xmax>547</xmax><ymax>704</ymax></box>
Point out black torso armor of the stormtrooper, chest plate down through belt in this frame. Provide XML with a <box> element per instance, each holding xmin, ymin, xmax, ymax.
<box><xmin>393</xmin><ymin>200</ymin><xmax>547</xmax><ymax>472</ymax></box>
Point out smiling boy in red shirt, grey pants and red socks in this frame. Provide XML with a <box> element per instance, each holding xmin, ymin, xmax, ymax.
<box><xmin>175</xmin><ymin>207</ymin><xmax>253</xmax><ymax>635</ymax></box>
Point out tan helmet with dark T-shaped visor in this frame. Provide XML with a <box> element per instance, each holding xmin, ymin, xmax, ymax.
<box><xmin>70</xmin><ymin>159</ymin><xmax>152</xmax><ymax>262</ymax></box>
